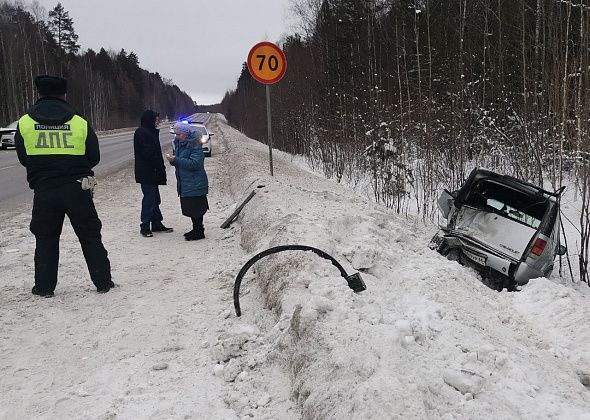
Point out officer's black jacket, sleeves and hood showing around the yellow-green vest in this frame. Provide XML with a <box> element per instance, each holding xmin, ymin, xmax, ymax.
<box><xmin>14</xmin><ymin>97</ymin><xmax>100</xmax><ymax>191</ymax></box>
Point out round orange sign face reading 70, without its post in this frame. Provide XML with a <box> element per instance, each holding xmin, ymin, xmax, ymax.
<box><xmin>248</xmin><ymin>42</ymin><xmax>287</xmax><ymax>85</ymax></box>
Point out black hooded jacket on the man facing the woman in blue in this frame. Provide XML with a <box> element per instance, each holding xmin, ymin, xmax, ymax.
<box><xmin>133</xmin><ymin>110</ymin><xmax>166</xmax><ymax>185</ymax></box>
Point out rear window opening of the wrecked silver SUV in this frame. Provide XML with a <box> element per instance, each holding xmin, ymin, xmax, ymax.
<box><xmin>467</xmin><ymin>180</ymin><xmax>549</xmax><ymax>229</ymax></box>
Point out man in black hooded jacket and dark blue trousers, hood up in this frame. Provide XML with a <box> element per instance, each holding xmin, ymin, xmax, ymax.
<box><xmin>133</xmin><ymin>109</ymin><xmax>173</xmax><ymax>237</ymax></box>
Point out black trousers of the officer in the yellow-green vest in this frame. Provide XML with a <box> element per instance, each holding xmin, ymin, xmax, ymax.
<box><xmin>30</xmin><ymin>182</ymin><xmax>111</xmax><ymax>292</ymax></box>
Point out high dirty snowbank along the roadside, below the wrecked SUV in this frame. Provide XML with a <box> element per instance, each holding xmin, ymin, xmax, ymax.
<box><xmin>220</xmin><ymin>116</ymin><xmax>590</xmax><ymax>419</ymax></box>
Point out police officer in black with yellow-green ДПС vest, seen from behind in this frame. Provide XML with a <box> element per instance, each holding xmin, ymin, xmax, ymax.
<box><xmin>15</xmin><ymin>75</ymin><xmax>115</xmax><ymax>297</ymax></box>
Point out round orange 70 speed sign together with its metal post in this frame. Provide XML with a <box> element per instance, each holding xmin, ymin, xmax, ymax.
<box><xmin>247</xmin><ymin>42</ymin><xmax>287</xmax><ymax>176</ymax></box>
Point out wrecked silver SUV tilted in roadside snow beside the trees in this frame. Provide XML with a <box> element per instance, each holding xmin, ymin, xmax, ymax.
<box><xmin>430</xmin><ymin>169</ymin><xmax>566</xmax><ymax>290</ymax></box>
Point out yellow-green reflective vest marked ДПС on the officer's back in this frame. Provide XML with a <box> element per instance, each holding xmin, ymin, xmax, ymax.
<box><xmin>18</xmin><ymin>114</ymin><xmax>88</xmax><ymax>156</ymax></box>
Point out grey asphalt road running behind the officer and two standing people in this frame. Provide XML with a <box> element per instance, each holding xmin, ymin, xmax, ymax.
<box><xmin>0</xmin><ymin>114</ymin><xmax>209</xmax><ymax>212</ymax></box>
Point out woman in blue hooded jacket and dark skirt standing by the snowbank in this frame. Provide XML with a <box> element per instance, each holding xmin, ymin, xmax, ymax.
<box><xmin>166</xmin><ymin>122</ymin><xmax>209</xmax><ymax>241</ymax></box>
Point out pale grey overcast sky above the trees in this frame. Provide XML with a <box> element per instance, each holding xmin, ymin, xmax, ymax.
<box><xmin>32</xmin><ymin>0</ymin><xmax>293</xmax><ymax>104</ymax></box>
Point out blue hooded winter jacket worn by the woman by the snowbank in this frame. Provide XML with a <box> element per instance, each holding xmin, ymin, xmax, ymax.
<box><xmin>170</xmin><ymin>131</ymin><xmax>209</xmax><ymax>197</ymax></box>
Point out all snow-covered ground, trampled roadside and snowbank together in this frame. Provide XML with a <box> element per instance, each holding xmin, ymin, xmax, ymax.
<box><xmin>0</xmin><ymin>113</ymin><xmax>590</xmax><ymax>419</ymax></box>
